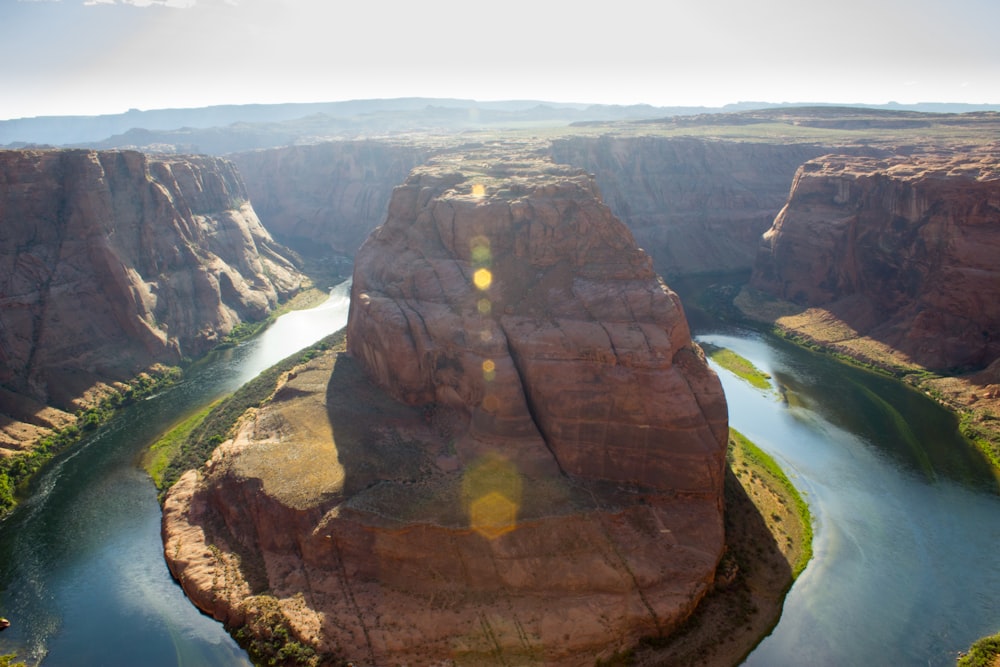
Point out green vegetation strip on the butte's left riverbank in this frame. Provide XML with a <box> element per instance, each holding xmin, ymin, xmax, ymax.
<box><xmin>152</xmin><ymin>330</ymin><xmax>344</xmax><ymax>492</ymax></box>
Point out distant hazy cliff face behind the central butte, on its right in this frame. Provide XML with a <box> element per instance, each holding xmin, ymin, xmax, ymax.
<box><xmin>551</xmin><ymin>135</ymin><xmax>829</xmax><ymax>276</ymax></box>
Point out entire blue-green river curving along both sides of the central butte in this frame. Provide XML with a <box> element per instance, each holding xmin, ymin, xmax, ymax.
<box><xmin>0</xmin><ymin>276</ymin><xmax>1000</xmax><ymax>667</ymax></box>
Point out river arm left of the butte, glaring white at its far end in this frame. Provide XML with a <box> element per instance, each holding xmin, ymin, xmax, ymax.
<box><xmin>0</xmin><ymin>283</ymin><xmax>350</xmax><ymax>667</ymax></box>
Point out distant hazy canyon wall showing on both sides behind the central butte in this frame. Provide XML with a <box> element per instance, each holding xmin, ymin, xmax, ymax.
<box><xmin>230</xmin><ymin>135</ymin><xmax>844</xmax><ymax>276</ymax></box>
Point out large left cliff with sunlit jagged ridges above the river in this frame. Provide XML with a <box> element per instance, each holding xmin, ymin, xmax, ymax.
<box><xmin>0</xmin><ymin>150</ymin><xmax>302</xmax><ymax>448</ymax></box>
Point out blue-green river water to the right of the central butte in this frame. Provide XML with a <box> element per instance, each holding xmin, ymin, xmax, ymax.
<box><xmin>698</xmin><ymin>330</ymin><xmax>1000</xmax><ymax>667</ymax></box>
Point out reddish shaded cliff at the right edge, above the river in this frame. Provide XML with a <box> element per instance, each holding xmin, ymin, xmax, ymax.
<box><xmin>751</xmin><ymin>151</ymin><xmax>1000</xmax><ymax>369</ymax></box>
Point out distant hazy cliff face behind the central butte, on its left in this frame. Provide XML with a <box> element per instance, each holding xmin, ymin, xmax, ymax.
<box><xmin>231</xmin><ymin>141</ymin><xmax>430</xmax><ymax>256</ymax></box>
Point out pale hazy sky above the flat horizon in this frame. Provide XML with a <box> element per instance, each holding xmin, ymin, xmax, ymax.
<box><xmin>0</xmin><ymin>0</ymin><xmax>1000</xmax><ymax>119</ymax></box>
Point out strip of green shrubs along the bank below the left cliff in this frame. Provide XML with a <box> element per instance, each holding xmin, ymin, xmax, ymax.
<box><xmin>0</xmin><ymin>366</ymin><xmax>180</xmax><ymax>516</ymax></box>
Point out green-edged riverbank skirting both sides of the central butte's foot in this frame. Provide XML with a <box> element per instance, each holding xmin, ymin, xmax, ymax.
<box><xmin>150</xmin><ymin>337</ymin><xmax>812</xmax><ymax>666</ymax></box>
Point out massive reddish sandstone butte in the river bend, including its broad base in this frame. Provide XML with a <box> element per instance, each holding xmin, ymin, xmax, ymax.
<box><xmin>163</xmin><ymin>150</ymin><xmax>728</xmax><ymax>665</ymax></box>
